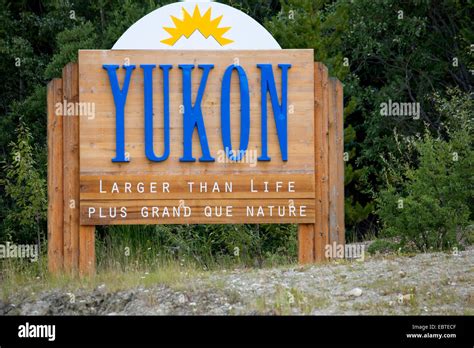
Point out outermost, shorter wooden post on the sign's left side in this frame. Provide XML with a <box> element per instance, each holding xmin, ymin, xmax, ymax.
<box><xmin>47</xmin><ymin>79</ymin><xmax>64</xmax><ymax>274</ymax></box>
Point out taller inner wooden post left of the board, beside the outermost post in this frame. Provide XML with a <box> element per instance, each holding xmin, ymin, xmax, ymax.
<box><xmin>63</xmin><ymin>63</ymin><xmax>79</xmax><ymax>274</ymax></box>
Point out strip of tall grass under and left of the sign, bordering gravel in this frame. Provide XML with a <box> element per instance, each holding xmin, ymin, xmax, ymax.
<box><xmin>0</xmin><ymin>225</ymin><xmax>297</xmax><ymax>301</ymax></box>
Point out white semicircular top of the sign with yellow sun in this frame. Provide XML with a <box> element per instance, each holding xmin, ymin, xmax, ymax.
<box><xmin>112</xmin><ymin>1</ymin><xmax>281</xmax><ymax>50</ymax></box>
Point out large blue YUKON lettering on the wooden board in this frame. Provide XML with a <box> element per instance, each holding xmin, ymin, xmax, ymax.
<box><xmin>102</xmin><ymin>64</ymin><xmax>291</xmax><ymax>162</ymax></box>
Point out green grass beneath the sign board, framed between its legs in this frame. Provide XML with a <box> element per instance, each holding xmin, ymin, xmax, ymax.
<box><xmin>97</xmin><ymin>225</ymin><xmax>297</xmax><ymax>270</ymax></box>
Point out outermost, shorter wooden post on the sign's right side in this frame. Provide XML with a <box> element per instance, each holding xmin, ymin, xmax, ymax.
<box><xmin>328</xmin><ymin>77</ymin><xmax>340</xmax><ymax>245</ymax></box>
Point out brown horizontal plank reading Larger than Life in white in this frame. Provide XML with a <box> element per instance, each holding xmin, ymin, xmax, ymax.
<box><xmin>81</xmin><ymin>174</ymin><xmax>315</xmax><ymax>200</ymax></box>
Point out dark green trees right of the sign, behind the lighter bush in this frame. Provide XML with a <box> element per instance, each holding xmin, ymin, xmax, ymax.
<box><xmin>266</xmin><ymin>0</ymin><xmax>474</xmax><ymax>239</ymax></box>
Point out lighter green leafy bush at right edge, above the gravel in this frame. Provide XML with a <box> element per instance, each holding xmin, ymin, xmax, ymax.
<box><xmin>377</xmin><ymin>89</ymin><xmax>474</xmax><ymax>251</ymax></box>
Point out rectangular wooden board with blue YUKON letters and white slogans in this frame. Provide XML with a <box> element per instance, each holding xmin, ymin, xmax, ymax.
<box><xmin>79</xmin><ymin>50</ymin><xmax>315</xmax><ymax>225</ymax></box>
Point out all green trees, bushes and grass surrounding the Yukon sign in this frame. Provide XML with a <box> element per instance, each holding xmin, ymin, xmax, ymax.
<box><xmin>0</xmin><ymin>0</ymin><xmax>474</xmax><ymax>282</ymax></box>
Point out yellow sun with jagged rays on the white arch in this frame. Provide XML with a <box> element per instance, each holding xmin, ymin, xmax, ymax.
<box><xmin>161</xmin><ymin>5</ymin><xmax>234</xmax><ymax>46</ymax></box>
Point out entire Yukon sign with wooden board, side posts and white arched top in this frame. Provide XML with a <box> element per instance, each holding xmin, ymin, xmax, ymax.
<box><xmin>48</xmin><ymin>1</ymin><xmax>344</xmax><ymax>275</ymax></box>
